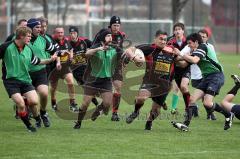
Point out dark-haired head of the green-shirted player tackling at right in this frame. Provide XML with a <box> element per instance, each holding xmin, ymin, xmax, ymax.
<box><xmin>187</xmin><ymin>33</ymin><xmax>203</xmax><ymax>50</ymax></box>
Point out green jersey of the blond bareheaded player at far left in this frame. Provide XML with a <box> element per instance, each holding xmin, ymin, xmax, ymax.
<box><xmin>0</xmin><ymin>41</ymin><xmax>40</xmax><ymax>83</ymax></box>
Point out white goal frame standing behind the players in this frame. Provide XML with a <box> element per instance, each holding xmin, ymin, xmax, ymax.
<box><xmin>88</xmin><ymin>18</ymin><xmax>173</xmax><ymax>44</ymax></box>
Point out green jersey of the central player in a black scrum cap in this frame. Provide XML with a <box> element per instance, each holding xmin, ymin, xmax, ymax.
<box><xmin>89</xmin><ymin>45</ymin><xmax>118</xmax><ymax>78</ymax></box>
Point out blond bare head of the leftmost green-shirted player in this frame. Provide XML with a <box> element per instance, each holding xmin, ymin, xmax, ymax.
<box><xmin>16</xmin><ymin>26</ymin><xmax>32</xmax><ymax>44</ymax></box>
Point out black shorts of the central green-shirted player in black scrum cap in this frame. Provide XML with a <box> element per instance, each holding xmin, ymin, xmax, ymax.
<box><xmin>83</xmin><ymin>78</ymin><xmax>112</xmax><ymax>96</ymax></box>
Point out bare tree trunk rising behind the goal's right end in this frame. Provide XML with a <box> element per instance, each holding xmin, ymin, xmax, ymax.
<box><xmin>172</xmin><ymin>0</ymin><xmax>189</xmax><ymax>23</ymax></box>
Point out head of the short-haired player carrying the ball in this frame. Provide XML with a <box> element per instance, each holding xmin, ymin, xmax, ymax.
<box><xmin>154</xmin><ymin>30</ymin><xmax>167</xmax><ymax>48</ymax></box>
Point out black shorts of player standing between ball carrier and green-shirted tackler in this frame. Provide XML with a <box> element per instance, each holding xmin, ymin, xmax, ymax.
<box><xmin>174</xmin><ymin>66</ymin><xmax>191</xmax><ymax>88</ymax></box>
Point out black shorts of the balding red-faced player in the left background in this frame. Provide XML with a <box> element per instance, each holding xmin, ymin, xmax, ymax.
<box><xmin>49</xmin><ymin>63</ymin><xmax>72</xmax><ymax>83</ymax></box>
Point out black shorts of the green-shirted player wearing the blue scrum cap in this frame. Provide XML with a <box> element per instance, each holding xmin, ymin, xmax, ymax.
<box><xmin>29</xmin><ymin>68</ymin><xmax>48</xmax><ymax>88</ymax></box>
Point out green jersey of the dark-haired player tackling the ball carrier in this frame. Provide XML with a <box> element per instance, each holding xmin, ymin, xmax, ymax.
<box><xmin>192</xmin><ymin>44</ymin><xmax>223</xmax><ymax>77</ymax></box>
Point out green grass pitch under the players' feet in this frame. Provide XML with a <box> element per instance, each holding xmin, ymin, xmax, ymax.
<box><xmin>0</xmin><ymin>54</ymin><xmax>240</xmax><ymax>159</ymax></box>
